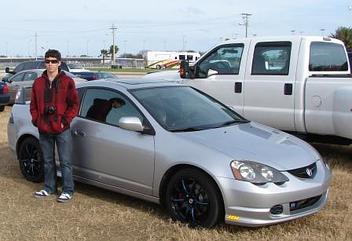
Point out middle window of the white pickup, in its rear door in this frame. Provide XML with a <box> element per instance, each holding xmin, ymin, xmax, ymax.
<box><xmin>252</xmin><ymin>42</ymin><xmax>291</xmax><ymax>75</ymax></box>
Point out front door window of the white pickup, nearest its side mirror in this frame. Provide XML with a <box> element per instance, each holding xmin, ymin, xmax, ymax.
<box><xmin>196</xmin><ymin>44</ymin><xmax>244</xmax><ymax>78</ymax></box>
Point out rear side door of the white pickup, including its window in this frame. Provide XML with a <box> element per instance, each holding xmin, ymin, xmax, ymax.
<box><xmin>243</xmin><ymin>41</ymin><xmax>298</xmax><ymax>130</ymax></box>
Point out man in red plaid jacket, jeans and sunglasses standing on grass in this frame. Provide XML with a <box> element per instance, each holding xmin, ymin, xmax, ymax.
<box><xmin>30</xmin><ymin>49</ymin><xmax>79</xmax><ymax>202</ymax></box>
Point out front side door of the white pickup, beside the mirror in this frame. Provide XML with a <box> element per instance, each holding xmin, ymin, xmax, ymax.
<box><xmin>182</xmin><ymin>43</ymin><xmax>248</xmax><ymax>114</ymax></box>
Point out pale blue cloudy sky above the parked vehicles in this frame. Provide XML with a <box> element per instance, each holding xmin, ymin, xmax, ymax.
<box><xmin>0</xmin><ymin>0</ymin><xmax>352</xmax><ymax>56</ymax></box>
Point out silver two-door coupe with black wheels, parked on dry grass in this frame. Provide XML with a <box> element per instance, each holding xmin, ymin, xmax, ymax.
<box><xmin>8</xmin><ymin>79</ymin><xmax>331</xmax><ymax>227</ymax></box>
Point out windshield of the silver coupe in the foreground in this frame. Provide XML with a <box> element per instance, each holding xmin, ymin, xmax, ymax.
<box><xmin>131</xmin><ymin>86</ymin><xmax>248</xmax><ymax>132</ymax></box>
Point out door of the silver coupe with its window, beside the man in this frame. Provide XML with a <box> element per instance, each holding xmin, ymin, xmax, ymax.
<box><xmin>71</xmin><ymin>88</ymin><xmax>154</xmax><ymax>195</ymax></box>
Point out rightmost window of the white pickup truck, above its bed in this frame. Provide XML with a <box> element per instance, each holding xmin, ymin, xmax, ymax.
<box><xmin>309</xmin><ymin>42</ymin><xmax>348</xmax><ymax>71</ymax></box>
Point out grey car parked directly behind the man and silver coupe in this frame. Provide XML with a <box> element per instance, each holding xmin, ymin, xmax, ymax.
<box><xmin>4</xmin><ymin>69</ymin><xmax>86</xmax><ymax>104</ymax></box>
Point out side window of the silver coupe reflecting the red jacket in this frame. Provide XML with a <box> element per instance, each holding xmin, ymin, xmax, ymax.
<box><xmin>80</xmin><ymin>89</ymin><xmax>143</xmax><ymax>125</ymax></box>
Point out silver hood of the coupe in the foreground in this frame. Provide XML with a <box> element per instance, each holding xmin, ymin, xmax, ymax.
<box><xmin>180</xmin><ymin>122</ymin><xmax>320</xmax><ymax>171</ymax></box>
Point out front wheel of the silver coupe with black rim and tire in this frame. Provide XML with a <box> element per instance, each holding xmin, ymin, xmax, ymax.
<box><xmin>165</xmin><ymin>168</ymin><xmax>224</xmax><ymax>228</ymax></box>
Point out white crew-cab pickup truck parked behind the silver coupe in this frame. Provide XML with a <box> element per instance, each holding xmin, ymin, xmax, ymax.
<box><xmin>145</xmin><ymin>36</ymin><xmax>352</xmax><ymax>144</ymax></box>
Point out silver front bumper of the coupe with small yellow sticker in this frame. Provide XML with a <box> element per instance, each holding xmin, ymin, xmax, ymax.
<box><xmin>219</xmin><ymin>161</ymin><xmax>331</xmax><ymax>227</ymax></box>
